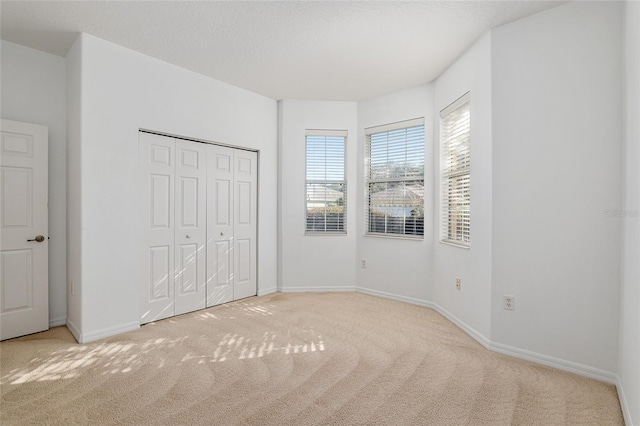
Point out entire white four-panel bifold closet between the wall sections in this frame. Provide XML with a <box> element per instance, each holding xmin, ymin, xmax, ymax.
<box><xmin>139</xmin><ymin>132</ymin><xmax>258</xmax><ymax>324</ymax></box>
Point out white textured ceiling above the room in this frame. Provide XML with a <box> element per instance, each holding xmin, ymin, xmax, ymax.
<box><xmin>0</xmin><ymin>1</ymin><xmax>562</xmax><ymax>100</ymax></box>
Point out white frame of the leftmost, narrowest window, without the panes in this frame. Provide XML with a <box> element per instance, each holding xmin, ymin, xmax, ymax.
<box><xmin>304</xmin><ymin>129</ymin><xmax>348</xmax><ymax>236</ymax></box>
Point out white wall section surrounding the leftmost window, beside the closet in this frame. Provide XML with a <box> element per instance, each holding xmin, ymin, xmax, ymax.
<box><xmin>279</xmin><ymin>100</ymin><xmax>359</xmax><ymax>292</ymax></box>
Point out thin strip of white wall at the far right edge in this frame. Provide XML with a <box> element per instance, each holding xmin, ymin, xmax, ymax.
<box><xmin>618</xmin><ymin>1</ymin><xmax>640</xmax><ymax>425</ymax></box>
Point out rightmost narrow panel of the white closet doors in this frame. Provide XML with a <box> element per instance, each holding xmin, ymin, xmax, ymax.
<box><xmin>233</xmin><ymin>150</ymin><xmax>258</xmax><ymax>300</ymax></box>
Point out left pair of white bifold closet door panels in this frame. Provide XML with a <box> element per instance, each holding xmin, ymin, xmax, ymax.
<box><xmin>139</xmin><ymin>133</ymin><xmax>207</xmax><ymax>324</ymax></box>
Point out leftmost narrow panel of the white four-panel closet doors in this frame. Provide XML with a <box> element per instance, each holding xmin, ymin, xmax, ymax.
<box><xmin>139</xmin><ymin>133</ymin><xmax>175</xmax><ymax>324</ymax></box>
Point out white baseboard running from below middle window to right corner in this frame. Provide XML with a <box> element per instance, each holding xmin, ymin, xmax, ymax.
<box><xmin>356</xmin><ymin>287</ymin><xmax>616</xmax><ymax>386</ymax></box>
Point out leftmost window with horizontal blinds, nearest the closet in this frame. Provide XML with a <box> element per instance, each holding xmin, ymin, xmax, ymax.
<box><xmin>305</xmin><ymin>130</ymin><xmax>347</xmax><ymax>234</ymax></box>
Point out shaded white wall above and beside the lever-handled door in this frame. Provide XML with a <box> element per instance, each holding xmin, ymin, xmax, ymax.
<box><xmin>0</xmin><ymin>41</ymin><xmax>67</xmax><ymax>326</ymax></box>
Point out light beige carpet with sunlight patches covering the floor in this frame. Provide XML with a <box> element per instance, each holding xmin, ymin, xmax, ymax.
<box><xmin>0</xmin><ymin>293</ymin><xmax>623</xmax><ymax>426</ymax></box>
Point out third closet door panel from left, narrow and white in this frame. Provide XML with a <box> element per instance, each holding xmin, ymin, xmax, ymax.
<box><xmin>207</xmin><ymin>145</ymin><xmax>234</xmax><ymax>307</ymax></box>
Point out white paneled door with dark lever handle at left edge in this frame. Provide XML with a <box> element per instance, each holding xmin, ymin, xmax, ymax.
<box><xmin>0</xmin><ymin>120</ymin><xmax>49</xmax><ymax>340</ymax></box>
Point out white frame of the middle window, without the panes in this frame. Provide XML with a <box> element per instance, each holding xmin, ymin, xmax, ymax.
<box><xmin>364</xmin><ymin>117</ymin><xmax>426</xmax><ymax>241</ymax></box>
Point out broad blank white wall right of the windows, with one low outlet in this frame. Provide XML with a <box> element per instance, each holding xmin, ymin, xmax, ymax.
<box><xmin>491</xmin><ymin>2</ymin><xmax>620</xmax><ymax>378</ymax></box>
